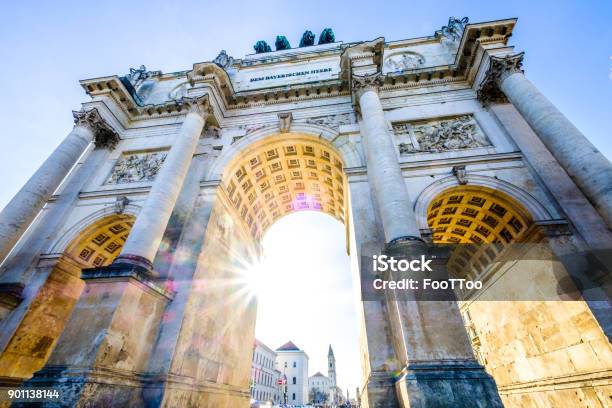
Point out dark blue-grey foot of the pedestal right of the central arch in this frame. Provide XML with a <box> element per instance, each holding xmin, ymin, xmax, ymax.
<box><xmin>395</xmin><ymin>360</ymin><xmax>503</xmax><ymax>408</ymax></box>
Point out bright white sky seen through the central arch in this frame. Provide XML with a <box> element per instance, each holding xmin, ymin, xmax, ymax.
<box><xmin>251</xmin><ymin>211</ymin><xmax>361</xmax><ymax>395</ymax></box>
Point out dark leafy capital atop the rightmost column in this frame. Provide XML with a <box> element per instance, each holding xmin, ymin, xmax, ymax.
<box><xmin>478</xmin><ymin>52</ymin><xmax>525</xmax><ymax>105</ymax></box>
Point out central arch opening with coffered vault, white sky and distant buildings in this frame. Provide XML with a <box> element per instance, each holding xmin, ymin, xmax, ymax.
<box><xmin>220</xmin><ymin>133</ymin><xmax>360</xmax><ymax>405</ymax></box>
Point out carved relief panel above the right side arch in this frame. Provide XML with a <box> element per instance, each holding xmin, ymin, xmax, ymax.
<box><xmin>393</xmin><ymin>115</ymin><xmax>491</xmax><ymax>155</ymax></box>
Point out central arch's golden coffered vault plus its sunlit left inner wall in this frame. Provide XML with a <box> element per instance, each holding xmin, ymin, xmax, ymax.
<box><xmin>153</xmin><ymin>133</ymin><xmax>356</xmax><ymax>406</ymax></box>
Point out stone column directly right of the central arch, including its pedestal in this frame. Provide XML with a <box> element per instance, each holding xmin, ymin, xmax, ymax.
<box><xmin>352</xmin><ymin>73</ymin><xmax>502</xmax><ymax>408</ymax></box>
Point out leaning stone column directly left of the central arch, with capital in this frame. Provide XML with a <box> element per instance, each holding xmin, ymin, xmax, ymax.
<box><xmin>114</xmin><ymin>97</ymin><xmax>210</xmax><ymax>271</ymax></box>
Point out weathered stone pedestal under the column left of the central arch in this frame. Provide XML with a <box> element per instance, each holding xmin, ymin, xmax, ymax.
<box><xmin>14</xmin><ymin>264</ymin><xmax>173</xmax><ymax>407</ymax></box>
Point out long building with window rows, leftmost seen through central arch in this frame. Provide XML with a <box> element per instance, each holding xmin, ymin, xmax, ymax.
<box><xmin>251</xmin><ymin>339</ymin><xmax>280</xmax><ymax>403</ymax></box>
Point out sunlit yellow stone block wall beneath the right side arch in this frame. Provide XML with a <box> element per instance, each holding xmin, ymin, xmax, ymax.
<box><xmin>462</xmin><ymin>247</ymin><xmax>612</xmax><ymax>408</ymax></box>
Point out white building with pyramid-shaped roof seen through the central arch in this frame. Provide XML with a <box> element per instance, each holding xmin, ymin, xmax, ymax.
<box><xmin>276</xmin><ymin>341</ymin><xmax>308</xmax><ymax>405</ymax></box>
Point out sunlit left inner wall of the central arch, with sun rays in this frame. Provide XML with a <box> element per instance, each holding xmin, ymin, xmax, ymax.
<box><xmin>162</xmin><ymin>191</ymin><xmax>258</xmax><ymax>407</ymax></box>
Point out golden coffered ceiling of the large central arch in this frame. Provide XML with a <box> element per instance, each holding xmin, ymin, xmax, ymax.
<box><xmin>222</xmin><ymin>133</ymin><xmax>347</xmax><ymax>239</ymax></box>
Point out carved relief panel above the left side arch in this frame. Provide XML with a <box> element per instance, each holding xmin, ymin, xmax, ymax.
<box><xmin>104</xmin><ymin>151</ymin><xmax>168</xmax><ymax>184</ymax></box>
